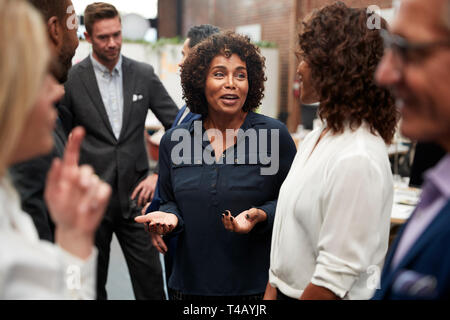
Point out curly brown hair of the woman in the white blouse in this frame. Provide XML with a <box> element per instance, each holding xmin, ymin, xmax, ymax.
<box><xmin>299</xmin><ymin>2</ymin><xmax>399</xmax><ymax>143</ymax></box>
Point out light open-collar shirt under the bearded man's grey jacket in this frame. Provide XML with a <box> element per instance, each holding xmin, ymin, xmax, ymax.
<box><xmin>90</xmin><ymin>53</ymin><xmax>123</xmax><ymax>140</ymax></box>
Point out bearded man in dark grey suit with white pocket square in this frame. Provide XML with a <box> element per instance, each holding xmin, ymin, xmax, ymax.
<box><xmin>63</xmin><ymin>2</ymin><xmax>178</xmax><ymax>299</ymax></box>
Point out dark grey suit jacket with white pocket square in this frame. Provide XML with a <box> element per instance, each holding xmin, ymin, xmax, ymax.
<box><xmin>62</xmin><ymin>57</ymin><xmax>178</xmax><ymax>218</ymax></box>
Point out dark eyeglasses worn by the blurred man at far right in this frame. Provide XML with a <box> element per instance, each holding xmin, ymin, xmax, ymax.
<box><xmin>380</xmin><ymin>29</ymin><xmax>450</xmax><ymax>63</ymax></box>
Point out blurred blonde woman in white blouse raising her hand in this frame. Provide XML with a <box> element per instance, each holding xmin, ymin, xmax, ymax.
<box><xmin>0</xmin><ymin>0</ymin><xmax>111</xmax><ymax>299</ymax></box>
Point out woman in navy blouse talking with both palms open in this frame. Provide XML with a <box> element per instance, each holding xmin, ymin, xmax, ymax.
<box><xmin>136</xmin><ymin>32</ymin><xmax>296</xmax><ymax>300</ymax></box>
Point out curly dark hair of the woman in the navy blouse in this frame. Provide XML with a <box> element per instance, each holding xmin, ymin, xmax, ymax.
<box><xmin>181</xmin><ymin>31</ymin><xmax>266</xmax><ymax>117</ymax></box>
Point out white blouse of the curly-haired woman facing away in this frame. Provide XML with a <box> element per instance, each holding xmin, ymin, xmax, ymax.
<box><xmin>269</xmin><ymin>124</ymin><xmax>393</xmax><ymax>299</ymax></box>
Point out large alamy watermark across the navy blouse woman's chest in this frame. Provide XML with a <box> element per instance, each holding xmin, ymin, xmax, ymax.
<box><xmin>170</xmin><ymin>121</ymin><xmax>280</xmax><ymax>175</ymax></box>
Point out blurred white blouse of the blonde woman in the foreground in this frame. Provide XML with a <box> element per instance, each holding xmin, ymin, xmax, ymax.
<box><xmin>0</xmin><ymin>177</ymin><xmax>97</xmax><ymax>300</ymax></box>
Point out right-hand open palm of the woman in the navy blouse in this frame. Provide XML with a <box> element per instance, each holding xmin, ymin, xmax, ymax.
<box><xmin>222</xmin><ymin>208</ymin><xmax>267</xmax><ymax>233</ymax></box>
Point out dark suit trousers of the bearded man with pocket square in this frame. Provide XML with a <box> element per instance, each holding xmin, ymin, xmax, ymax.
<box><xmin>95</xmin><ymin>182</ymin><xmax>165</xmax><ymax>300</ymax></box>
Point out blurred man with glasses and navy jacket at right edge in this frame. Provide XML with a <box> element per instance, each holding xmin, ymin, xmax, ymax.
<box><xmin>374</xmin><ymin>0</ymin><xmax>450</xmax><ymax>299</ymax></box>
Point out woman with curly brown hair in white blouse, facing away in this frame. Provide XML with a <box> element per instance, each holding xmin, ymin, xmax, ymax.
<box><xmin>265</xmin><ymin>2</ymin><xmax>398</xmax><ymax>299</ymax></box>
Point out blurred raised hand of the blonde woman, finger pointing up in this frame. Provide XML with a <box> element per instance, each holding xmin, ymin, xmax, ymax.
<box><xmin>44</xmin><ymin>127</ymin><xmax>111</xmax><ymax>258</ymax></box>
